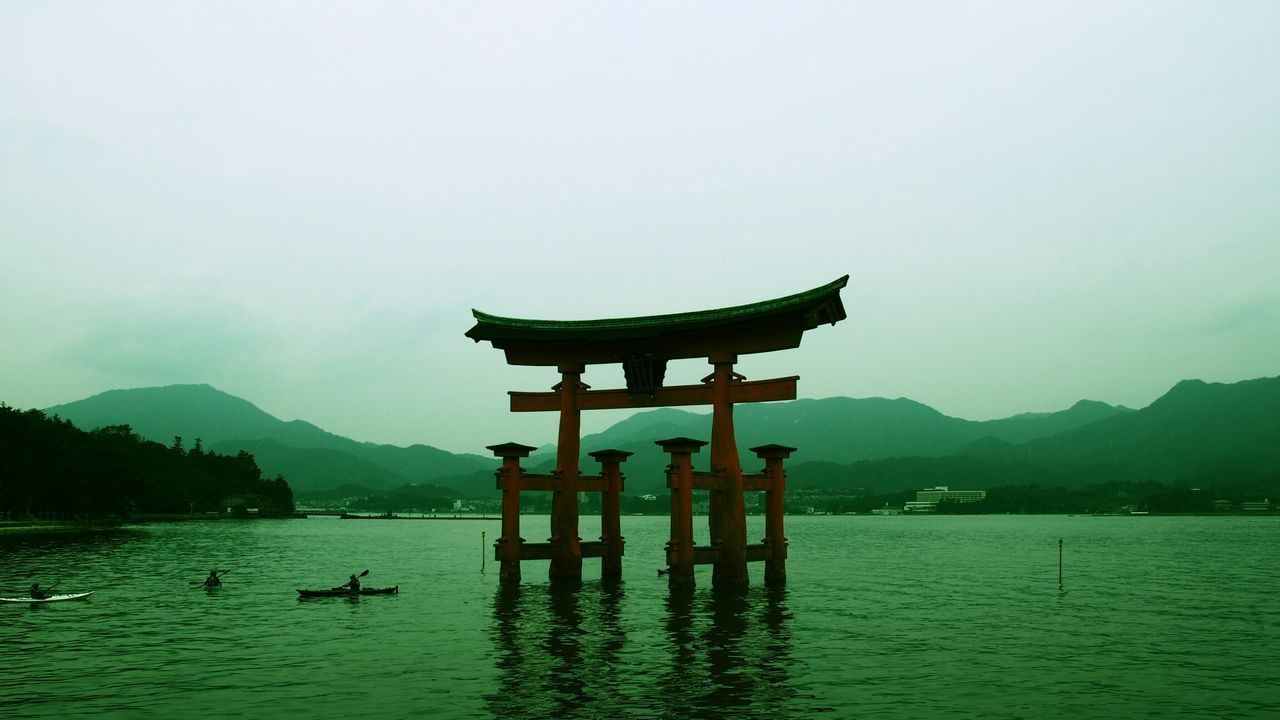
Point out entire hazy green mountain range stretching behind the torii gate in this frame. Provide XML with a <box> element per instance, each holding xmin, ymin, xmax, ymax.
<box><xmin>45</xmin><ymin>378</ymin><xmax>1280</xmax><ymax>498</ymax></box>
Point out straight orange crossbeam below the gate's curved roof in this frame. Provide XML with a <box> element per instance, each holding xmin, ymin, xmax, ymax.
<box><xmin>507</xmin><ymin>375</ymin><xmax>800</xmax><ymax>413</ymax></box>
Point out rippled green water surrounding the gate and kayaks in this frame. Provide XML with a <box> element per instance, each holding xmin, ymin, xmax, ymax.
<box><xmin>0</xmin><ymin>516</ymin><xmax>1280</xmax><ymax>719</ymax></box>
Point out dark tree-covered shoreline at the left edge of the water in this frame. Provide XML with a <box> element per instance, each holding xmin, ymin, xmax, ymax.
<box><xmin>0</xmin><ymin>402</ymin><xmax>293</xmax><ymax>520</ymax></box>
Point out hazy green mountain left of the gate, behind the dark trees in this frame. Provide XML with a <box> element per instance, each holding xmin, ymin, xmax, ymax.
<box><xmin>45</xmin><ymin>384</ymin><xmax>494</xmax><ymax>496</ymax></box>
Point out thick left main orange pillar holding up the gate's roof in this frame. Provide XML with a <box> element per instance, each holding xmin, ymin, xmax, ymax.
<box><xmin>548</xmin><ymin>365</ymin><xmax>582</xmax><ymax>580</ymax></box>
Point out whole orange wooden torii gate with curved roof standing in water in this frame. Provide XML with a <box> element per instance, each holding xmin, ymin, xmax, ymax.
<box><xmin>466</xmin><ymin>275</ymin><xmax>849</xmax><ymax>587</ymax></box>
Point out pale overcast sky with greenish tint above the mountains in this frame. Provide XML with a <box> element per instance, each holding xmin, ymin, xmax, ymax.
<box><xmin>0</xmin><ymin>0</ymin><xmax>1280</xmax><ymax>454</ymax></box>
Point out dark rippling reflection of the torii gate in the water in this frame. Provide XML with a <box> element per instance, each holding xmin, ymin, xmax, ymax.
<box><xmin>486</xmin><ymin>580</ymin><xmax>796</xmax><ymax>717</ymax></box>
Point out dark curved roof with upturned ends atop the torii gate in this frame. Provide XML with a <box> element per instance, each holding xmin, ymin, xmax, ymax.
<box><xmin>466</xmin><ymin>275</ymin><xmax>849</xmax><ymax>365</ymax></box>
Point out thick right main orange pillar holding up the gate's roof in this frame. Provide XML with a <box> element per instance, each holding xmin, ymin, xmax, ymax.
<box><xmin>710</xmin><ymin>354</ymin><xmax>748</xmax><ymax>587</ymax></box>
